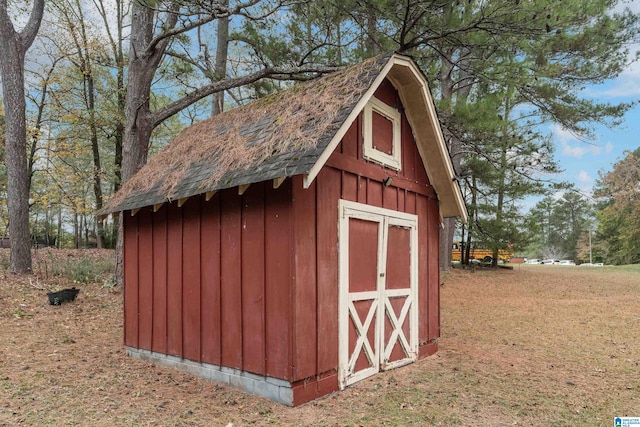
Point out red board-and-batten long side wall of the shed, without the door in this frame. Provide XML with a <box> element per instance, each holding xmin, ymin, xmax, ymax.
<box><xmin>124</xmin><ymin>184</ymin><xmax>296</xmax><ymax>379</ymax></box>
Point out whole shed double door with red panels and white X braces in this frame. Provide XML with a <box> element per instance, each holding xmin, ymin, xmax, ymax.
<box><xmin>338</xmin><ymin>200</ymin><xmax>418</xmax><ymax>389</ymax></box>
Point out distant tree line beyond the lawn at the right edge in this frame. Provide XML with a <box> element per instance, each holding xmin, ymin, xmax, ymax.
<box><xmin>522</xmin><ymin>147</ymin><xmax>640</xmax><ymax>264</ymax></box>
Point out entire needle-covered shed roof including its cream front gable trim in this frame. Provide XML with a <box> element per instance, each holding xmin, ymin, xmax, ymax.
<box><xmin>100</xmin><ymin>54</ymin><xmax>467</xmax><ymax>221</ymax></box>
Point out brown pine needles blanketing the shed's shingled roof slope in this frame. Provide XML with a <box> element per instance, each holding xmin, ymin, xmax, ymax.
<box><xmin>103</xmin><ymin>57</ymin><xmax>386</xmax><ymax>211</ymax></box>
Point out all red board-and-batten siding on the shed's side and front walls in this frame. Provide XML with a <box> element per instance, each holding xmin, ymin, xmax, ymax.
<box><xmin>124</xmin><ymin>77</ymin><xmax>440</xmax><ymax>405</ymax></box>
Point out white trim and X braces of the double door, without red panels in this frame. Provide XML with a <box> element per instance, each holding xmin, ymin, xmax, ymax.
<box><xmin>338</xmin><ymin>200</ymin><xmax>418</xmax><ymax>389</ymax></box>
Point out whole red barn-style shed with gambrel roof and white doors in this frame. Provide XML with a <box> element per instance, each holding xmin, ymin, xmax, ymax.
<box><xmin>103</xmin><ymin>54</ymin><xmax>466</xmax><ymax>405</ymax></box>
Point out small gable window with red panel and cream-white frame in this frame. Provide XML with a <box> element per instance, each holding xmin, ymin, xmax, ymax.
<box><xmin>363</xmin><ymin>97</ymin><xmax>402</xmax><ymax>170</ymax></box>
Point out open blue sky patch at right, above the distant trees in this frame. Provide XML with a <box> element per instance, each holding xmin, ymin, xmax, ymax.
<box><xmin>551</xmin><ymin>0</ymin><xmax>640</xmax><ymax>201</ymax></box>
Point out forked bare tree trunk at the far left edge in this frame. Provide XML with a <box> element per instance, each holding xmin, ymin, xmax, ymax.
<box><xmin>0</xmin><ymin>0</ymin><xmax>44</xmax><ymax>273</ymax></box>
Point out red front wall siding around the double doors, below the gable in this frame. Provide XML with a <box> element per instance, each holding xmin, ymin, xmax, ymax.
<box><xmin>294</xmin><ymin>172</ymin><xmax>439</xmax><ymax>372</ymax></box>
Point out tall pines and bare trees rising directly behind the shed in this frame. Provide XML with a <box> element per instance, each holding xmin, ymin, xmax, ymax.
<box><xmin>0</xmin><ymin>0</ymin><xmax>638</xmax><ymax>272</ymax></box>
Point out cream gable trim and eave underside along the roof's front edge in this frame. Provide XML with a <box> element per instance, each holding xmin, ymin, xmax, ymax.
<box><xmin>303</xmin><ymin>54</ymin><xmax>467</xmax><ymax>223</ymax></box>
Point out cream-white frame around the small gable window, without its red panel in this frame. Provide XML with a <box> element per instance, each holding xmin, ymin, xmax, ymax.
<box><xmin>362</xmin><ymin>96</ymin><xmax>402</xmax><ymax>171</ymax></box>
